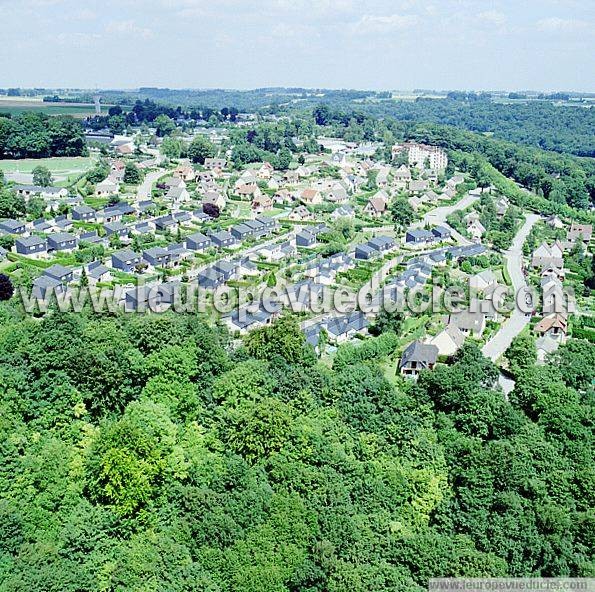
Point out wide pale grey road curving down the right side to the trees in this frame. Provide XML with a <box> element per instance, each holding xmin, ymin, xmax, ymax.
<box><xmin>481</xmin><ymin>214</ymin><xmax>539</xmax><ymax>364</ymax></box>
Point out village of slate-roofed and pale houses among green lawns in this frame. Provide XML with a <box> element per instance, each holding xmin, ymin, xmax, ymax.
<box><xmin>0</xmin><ymin>121</ymin><xmax>592</xmax><ymax>378</ymax></box>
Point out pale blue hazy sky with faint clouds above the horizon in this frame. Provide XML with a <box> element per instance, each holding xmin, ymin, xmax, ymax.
<box><xmin>0</xmin><ymin>0</ymin><xmax>595</xmax><ymax>91</ymax></box>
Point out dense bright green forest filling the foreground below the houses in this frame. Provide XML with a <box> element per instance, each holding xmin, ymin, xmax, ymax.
<box><xmin>0</xmin><ymin>301</ymin><xmax>595</xmax><ymax>592</ymax></box>
